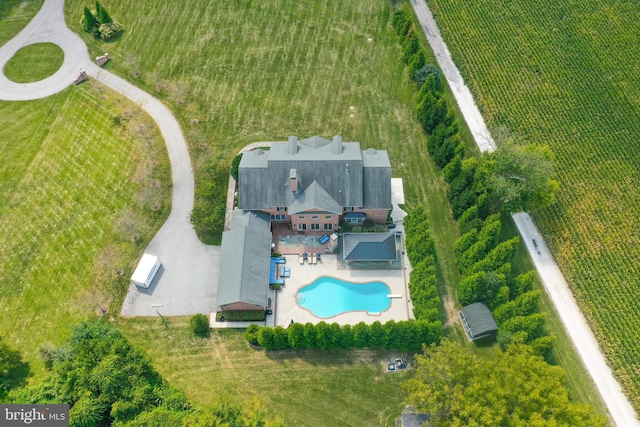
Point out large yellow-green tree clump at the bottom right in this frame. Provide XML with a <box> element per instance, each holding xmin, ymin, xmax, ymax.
<box><xmin>404</xmin><ymin>340</ymin><xmax>607</xmax><ymax>427</ymax></box>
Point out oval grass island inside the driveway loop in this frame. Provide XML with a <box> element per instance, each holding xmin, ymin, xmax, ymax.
<box><xmin>4</xmin><ymin>43</ymin><xmax>64</xmax><ymax>83</ymax></box>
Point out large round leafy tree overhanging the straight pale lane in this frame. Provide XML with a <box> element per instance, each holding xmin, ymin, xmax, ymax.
<box><xmin>483</xmin><ymin>129</ymin><xmax>559</xmax><ymax>213</ymax></box>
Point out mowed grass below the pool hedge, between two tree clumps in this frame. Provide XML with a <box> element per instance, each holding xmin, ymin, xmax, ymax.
<box><xmin>117</xmin><ymin>318</ymin><xmax>411</xmax><ymax>427</ymax></box>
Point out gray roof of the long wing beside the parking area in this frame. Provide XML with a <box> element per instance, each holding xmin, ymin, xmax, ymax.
<box><xmin>216</xmin><ymin>210</ymin><xmax>271</xmax><ymax>307</ymax></box>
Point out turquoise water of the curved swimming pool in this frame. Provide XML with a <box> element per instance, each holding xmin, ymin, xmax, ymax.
<box><xmin>296</xmin><ymin>276</ymin><xmax>391</xmax><ymax>319</ymax></box>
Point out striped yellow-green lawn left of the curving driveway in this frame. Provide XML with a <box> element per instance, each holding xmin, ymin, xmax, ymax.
<box><xmin>0</xmin><ymin>83</ymin><xmax>171</xmax><ymax>379</ymax></box>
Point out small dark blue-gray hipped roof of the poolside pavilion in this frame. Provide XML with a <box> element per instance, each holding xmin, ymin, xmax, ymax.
<box><xmin>342</xmin><ymin>233</ymin><xmax>398</xmax><ymax>261</ymax></box>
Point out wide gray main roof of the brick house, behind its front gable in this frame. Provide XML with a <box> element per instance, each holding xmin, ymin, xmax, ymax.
<box><xmin>238</xmin><ymin>136</ymin><xmax>391</xmax><ymax>209</ymax></box>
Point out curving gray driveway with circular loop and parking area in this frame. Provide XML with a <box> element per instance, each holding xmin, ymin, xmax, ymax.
<box><xmin>0</xmin><ymin>0</ymin><xmax>220</xmax><ymax>316</ymax></box>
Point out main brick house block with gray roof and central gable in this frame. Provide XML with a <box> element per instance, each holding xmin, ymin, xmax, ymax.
<box><xmin>238</xmin><ymin>136</ymin><xmax>391</xmax><ymax>233</ymax></box>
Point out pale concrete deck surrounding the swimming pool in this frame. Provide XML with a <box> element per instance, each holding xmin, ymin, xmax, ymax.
<box><xmin>274</xmin><ymin>254</ymin><xmax>412</xmax><ymax>327</ymax></box>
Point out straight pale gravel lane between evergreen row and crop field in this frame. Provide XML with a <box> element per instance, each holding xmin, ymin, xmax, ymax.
<box><xmin>411</xmin><ymin>0</ymin><xmax>640</xmax><ymax>427</ymax></box>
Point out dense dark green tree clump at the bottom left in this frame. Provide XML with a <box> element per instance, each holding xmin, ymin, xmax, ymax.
<box><xmin>9</xmin><ymin>320</ymin><xmax>281</xmax><ymax>427</ymax></box>
